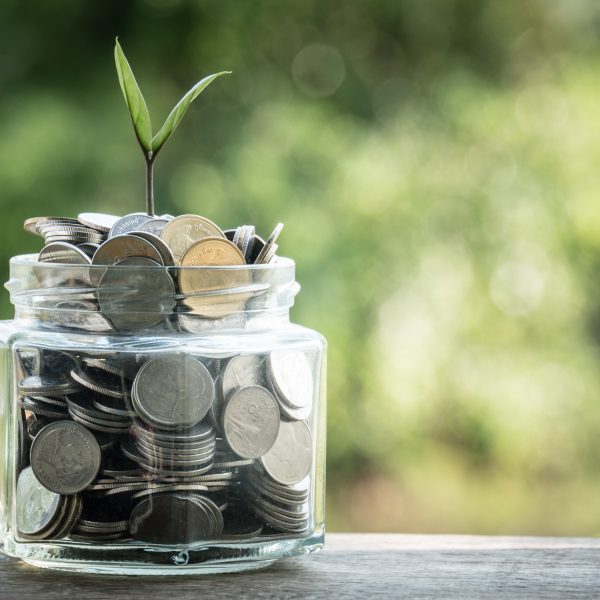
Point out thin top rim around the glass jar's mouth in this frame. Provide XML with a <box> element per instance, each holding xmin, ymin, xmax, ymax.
<box><xmin>10</xmin><ymin>254</ymin><xmax>295</xmax><ymax>273</ymax></box>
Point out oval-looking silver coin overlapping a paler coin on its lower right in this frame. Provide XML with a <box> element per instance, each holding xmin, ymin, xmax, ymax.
<box><xmin>222</xmin><ymin>385</ymin><xmax>279</xmax><ymax>459</ymax></box>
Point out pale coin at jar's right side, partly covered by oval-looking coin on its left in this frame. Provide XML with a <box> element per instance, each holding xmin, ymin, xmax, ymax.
<box><xmin>260</xmin><ymin>421</ymin><xmax>312</xmax><ymax>484</ymax></box>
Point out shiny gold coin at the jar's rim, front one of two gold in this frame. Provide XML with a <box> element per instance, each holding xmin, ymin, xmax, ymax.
<box><xmin>179</xmin><ymin>237</ymin><xmax>250</xmax><ymax>319</ymax></box>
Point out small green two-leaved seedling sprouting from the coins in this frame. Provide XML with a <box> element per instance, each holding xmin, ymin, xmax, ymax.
<box><xmin>115</xmin><ymin>39</ymin><xmax>231</xmax><ymax>216</ymax></box>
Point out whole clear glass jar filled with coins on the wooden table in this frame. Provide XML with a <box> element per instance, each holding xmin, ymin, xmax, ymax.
<box><xmin>0</xmin><ymin>255</ymin><xmax>326</xmax><ymax>574</ymax></box>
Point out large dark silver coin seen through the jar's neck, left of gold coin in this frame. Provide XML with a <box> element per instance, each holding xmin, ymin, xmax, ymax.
<box><xmin>98</xmin><ymin>254</ymin><xmax>176</xmax><ymax>331</ymax></box>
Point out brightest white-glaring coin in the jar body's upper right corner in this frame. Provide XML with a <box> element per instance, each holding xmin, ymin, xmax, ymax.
<box><xmin>267</xmin><ymin>349</ymin><xmax>314</xmax><ymax>409</ymax></box>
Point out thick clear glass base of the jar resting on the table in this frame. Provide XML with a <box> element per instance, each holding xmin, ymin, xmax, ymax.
<box><xmin>4</xmin><ymin>533</ymin><xmax>324</xmax><ymax>576</ymax></box>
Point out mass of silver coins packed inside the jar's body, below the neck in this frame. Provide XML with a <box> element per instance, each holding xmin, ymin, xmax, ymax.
<box><xmin>15</xmin><ymin>342</ymin><xmax>318</xmax><ymax>545</ymax></box>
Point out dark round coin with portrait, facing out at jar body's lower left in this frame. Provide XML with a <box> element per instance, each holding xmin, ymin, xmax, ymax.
<box><xmin>31</xmin><ymin>421</ymin><xmax>101</xmax><ymax>494</ymax></box>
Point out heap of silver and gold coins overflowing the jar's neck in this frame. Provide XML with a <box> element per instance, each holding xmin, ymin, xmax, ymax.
<box><xmin>24</xmin><ymin>213</ymin><xmax>283</xmax><ymax>331</ymax></box>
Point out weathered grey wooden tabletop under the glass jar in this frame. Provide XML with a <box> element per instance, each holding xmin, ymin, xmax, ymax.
<box><xmin>0</xmin><ymin>534</ymin><xmax>600</xmax><ymax>600</ymax></box>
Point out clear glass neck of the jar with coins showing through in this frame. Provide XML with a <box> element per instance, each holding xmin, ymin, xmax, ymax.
<box><xmin>6</xmin><ymin>256</ymin><xmax>300</xmax><ymax>334</ymax></box>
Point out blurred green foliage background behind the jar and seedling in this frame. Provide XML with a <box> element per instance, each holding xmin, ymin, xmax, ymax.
<box><xmin>0</xmin><ymin>0</ymin><xmax>600</xmax><ymax>535</ymax></box>
